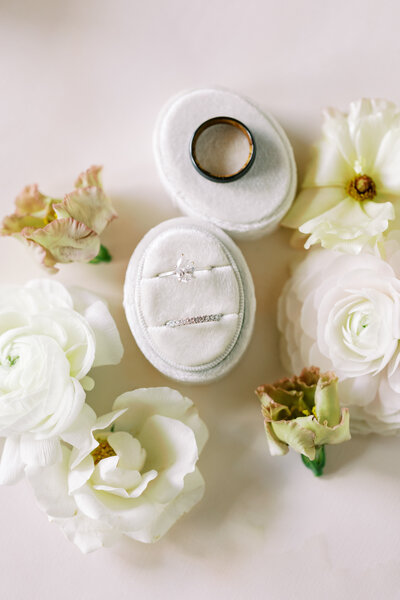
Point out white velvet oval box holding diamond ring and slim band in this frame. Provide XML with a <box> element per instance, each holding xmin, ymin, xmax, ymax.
<box><xmin>124</xmin><ymin>217</ymin><xmax>256</xmax><ymax>383</ymax></box>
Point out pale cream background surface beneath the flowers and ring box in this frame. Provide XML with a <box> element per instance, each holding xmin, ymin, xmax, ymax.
<box><xmin>0</xmin><ymin>0</ymin><xmax>400</xmax><ymax>600</ymax></box>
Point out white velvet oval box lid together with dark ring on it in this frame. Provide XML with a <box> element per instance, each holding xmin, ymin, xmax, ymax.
<box><xmin>154</xmin><ymin>88</ymin><xmax>297</xmax><ymax>238</ymax></box>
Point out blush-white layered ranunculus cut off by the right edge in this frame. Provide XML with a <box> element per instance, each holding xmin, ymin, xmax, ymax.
<box><xmin>278</xmin><ymin>240</ymin><xmax>400</xmax><ymax>434</ymax></box>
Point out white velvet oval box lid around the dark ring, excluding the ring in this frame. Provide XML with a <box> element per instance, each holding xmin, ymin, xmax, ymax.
<box><xmin>154</xmin><ymin>88</ymin><xmax>297</xmax><ymax>238</ymax></box>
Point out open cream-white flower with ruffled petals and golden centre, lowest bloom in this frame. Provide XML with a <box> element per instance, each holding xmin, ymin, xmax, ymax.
<box><xmin>27</xmin><ymin>388</ymin><xmax>208</xmax><ymax>553</ymax></box>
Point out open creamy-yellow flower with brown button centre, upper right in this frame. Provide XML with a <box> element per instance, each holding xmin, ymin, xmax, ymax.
<box><xmin>283</xmin><ymin>99</ymin><xmax>400</xmax><ymax>254</ymax></box>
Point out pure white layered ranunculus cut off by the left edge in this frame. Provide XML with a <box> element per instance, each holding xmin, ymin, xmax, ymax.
<box><xmin>0</xmin><ymin>279</ymin><xmax>123</xmax><ymax>483</ymax></box>
